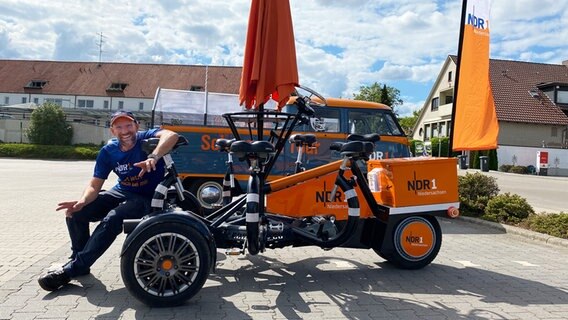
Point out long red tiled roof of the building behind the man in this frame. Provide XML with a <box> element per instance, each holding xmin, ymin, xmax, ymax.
<box><xmin>0</xmin><ymin>60</ymin><xmax>242</xmax><ymax>99</ymax></box>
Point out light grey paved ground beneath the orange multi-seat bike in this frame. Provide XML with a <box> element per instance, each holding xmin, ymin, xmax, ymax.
<box><xmin>0</xmin><ymin>159</ymin><xmax>568</xmax><ymax>319</ymax></box>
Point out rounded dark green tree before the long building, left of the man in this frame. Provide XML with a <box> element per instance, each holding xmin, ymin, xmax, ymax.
<box><xmin>27</xmin><ymin>102</ymin><xmax>73</xmax><ymax>145</ymax></box>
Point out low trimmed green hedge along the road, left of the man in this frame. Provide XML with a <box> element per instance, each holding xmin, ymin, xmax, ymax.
<box><xmin>0</xmin><ymin>143</ymin><xmax>99</xmax><ymax>160</ymax></box>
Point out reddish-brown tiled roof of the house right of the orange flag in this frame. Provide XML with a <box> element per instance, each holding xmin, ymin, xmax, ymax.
<box><xmin>489</xmin><ymin>59</ymin><xmax>568</xmax><ymax>125</ymax></box>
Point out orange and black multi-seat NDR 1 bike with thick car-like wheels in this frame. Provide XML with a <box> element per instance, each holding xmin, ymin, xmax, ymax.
<box><xmin>121</xmin><ymin>87</ymin><xmax>458</xmax><ymax>306</ymax></box>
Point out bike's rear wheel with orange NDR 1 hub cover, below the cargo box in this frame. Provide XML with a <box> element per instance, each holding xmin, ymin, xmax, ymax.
<box><xmin>375</xmin><ymin>216</ymin><xmax>442</xmax><ymax>270</ymax></box>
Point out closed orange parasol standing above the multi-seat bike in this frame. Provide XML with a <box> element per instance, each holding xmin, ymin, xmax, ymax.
<box><xmin>239</xmin><ymin>0</ymin><xmax>298</xmax><ymax>110</ymax></box>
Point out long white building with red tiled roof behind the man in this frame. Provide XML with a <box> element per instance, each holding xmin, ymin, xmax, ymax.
<box><xmin>0</xmin><ymin>60</ymin><xmax>242</xmax><ymax>143</ymax></box>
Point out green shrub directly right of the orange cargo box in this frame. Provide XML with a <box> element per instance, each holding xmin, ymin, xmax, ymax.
<box><xmin>458</xmin><ymin>172</ymin><xmax>499</xmax><ymax>216</ymax></box>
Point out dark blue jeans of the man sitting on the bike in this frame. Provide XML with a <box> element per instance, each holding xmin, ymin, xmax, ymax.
<box><xmin>64</xmin><ymin>189</ymin><xmax>151</xmax><ymax>277</ymax></box>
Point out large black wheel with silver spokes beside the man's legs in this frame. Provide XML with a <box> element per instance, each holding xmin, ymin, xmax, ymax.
<box><xmin>120</xmin><ymin>223</ymin><xmax>211</xmax><ymax>307</ymax></box>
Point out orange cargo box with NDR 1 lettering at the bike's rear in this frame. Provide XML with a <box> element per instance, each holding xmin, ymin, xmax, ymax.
<box><xmin>367</xmin><ymin>157</ymin><xmax>459</xmax><ymax>207</ymax></box>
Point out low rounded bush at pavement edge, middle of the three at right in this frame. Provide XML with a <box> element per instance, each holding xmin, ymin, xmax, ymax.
<box><xmin>483</xmin><ymin>193</ymin><xmax>534</xmax><ymax>224</ymax></box>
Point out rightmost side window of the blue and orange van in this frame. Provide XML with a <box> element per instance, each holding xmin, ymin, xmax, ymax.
<box><xmin>349</xmin><ymin>110</ymin><xmax>403</xmax><ymax>136</ymax></box>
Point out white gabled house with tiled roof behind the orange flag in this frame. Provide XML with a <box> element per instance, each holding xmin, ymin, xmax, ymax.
<box><xmin>412</xmin><ymin>55</ymin><xmax>568</xmax><ymax>173</ymax></box>
